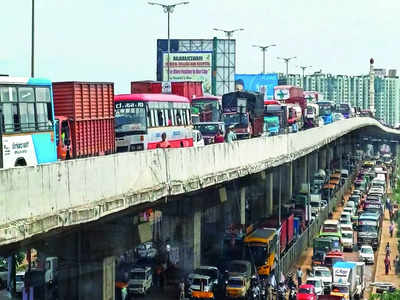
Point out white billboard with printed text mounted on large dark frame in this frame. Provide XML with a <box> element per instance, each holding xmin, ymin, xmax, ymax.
<box><xmin>162</xmin><ymin>52</ymin><xmax>212</xmax><ymax>94</ymax></box>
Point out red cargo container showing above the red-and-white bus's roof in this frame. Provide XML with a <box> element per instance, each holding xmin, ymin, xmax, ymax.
<box><xmin>131</xmin><ymin>80</ymin><xmax>203</xmax><ymax>100</ymax></box>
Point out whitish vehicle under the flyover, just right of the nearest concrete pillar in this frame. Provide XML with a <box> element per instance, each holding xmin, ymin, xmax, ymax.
<box><xmin>128</xmin><ymin>267</ymin><xmax>153</xmax><ymax>296</ymax></box>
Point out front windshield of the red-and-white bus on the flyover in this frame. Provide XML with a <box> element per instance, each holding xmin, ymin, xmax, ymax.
<box><xmin>115</xmin><ymin>107</ymin><xmax>146</xmax><ymax>131</ymax></box>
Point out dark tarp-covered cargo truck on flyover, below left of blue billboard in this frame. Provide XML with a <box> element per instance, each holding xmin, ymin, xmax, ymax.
<box><xmin>222</xmin><ymin>91</ymin><xmax>264</xmax><ymax>139</ymax></box>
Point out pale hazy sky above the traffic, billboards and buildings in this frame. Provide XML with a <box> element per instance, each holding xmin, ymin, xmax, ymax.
<box><xmin>0</xmin><ymin>0</ymin><xmax>400</xmax><ymax>93</ymax></box>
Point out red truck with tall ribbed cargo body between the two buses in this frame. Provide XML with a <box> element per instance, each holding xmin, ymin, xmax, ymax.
<box><xmin>53</xmin><ymin>81</ymin><xmax>115</xmax><ymax>160</ymax></box>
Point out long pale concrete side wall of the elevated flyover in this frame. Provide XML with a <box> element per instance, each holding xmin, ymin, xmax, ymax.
<box><xmin>0</xmin><ymin>118</ymin><xmax>400</xmax><ymax>245</ymax></box>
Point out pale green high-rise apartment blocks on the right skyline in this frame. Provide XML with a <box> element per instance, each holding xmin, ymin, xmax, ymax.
<box><xmin>279</xmin><ymin>68</ymin><xmax>400</xmax><ymax>126</ymax></box>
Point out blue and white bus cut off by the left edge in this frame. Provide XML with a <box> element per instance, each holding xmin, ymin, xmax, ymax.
<box><xmin>0</xmin><ymin>76</ymin><xmax>57</xmax><ymax>168</ymax></box>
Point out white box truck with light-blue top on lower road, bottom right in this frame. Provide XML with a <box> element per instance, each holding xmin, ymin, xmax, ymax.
<box><xmin>331</xmin><ymin>262</ymin><xmax>357</xmax><ymax>300</ymax></box>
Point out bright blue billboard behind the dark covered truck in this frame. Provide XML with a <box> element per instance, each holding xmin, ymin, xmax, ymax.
<box><xmin>235</xmin><ymin>73</ymin><xmax>278</xmax><ymax>100</ymax></box>
